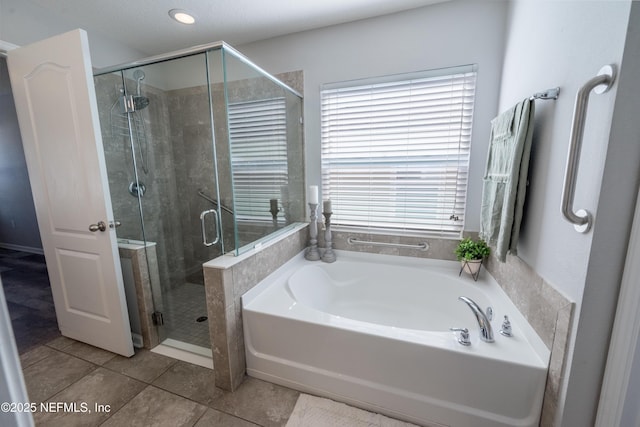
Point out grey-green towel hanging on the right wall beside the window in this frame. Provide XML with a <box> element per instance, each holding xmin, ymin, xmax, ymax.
<box><xmin>479</xmin><ymin>98</ymin><xmax>535</xmax><ymax>262</ymax></box>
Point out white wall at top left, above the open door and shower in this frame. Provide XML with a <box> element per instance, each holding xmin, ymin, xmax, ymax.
<box><xmin>0</xmin><ymin>0</ymin><xmax>142</xmax><ymax>68</ymax></box>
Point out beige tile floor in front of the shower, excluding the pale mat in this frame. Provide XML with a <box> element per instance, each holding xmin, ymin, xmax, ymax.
<box><xmin>20</xmin><ymin>337</ymin><xmax>299</xmax><ymax>427</ymax></box>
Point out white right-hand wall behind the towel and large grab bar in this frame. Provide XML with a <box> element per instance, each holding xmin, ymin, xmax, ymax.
<box><xmin>499</xmin><ymin>0</ymin><xmax>640</xmax><ymax>426</ymax></box>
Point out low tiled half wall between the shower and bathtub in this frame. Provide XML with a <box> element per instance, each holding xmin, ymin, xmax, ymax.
<box><xmin>204</xmin><ymin>225</ymin><xmax>308</xmax><ymax>391</ymax></box>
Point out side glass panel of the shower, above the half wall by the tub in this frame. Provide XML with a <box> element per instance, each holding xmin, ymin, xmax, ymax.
<box><xmin>212</xmin><ymin>49</ymin><xmax>304</xmax><ymax>254</ymax></box>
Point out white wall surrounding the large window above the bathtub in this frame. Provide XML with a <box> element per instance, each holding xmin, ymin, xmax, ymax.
<box><xmin>236</xmin><ymin>0</ymin><xmax>510</xmax><ymax>230</ymax></box>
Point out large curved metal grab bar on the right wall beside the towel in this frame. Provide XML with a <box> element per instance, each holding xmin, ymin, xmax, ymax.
<box><xmin>562</xmin><ymin>64</ymin><xmax>616</xmax><ymax>233</ymax></box>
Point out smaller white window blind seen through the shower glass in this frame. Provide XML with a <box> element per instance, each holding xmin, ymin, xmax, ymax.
<box><xmin>229</xmin><ymin>98</ymin><xmax>287</xmax><ymax>221</ymax></box>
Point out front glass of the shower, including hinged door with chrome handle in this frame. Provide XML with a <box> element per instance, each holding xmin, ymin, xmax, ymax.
<box><xmin>99</xmin><ymin>53</ymin><xmax>224</xmax><ymax>357</ymax></box>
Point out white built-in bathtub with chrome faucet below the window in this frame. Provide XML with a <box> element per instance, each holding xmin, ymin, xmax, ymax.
<box><xmin>242</xmin><ymin>251</ymin><xmax>549</xmax><ymax>427</ymax></box>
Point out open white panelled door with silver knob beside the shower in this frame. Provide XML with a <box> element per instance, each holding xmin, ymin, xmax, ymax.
<box><xmin>7</xmin><ymin>30</ymin><xmax>133</xmax><ymax>356</ymax></box>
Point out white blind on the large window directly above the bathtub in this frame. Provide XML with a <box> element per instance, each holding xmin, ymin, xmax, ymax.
<box><xmin>321</xmin><ymin>66</ymin><xmax>476</xmax><ymax>237</ymax></box>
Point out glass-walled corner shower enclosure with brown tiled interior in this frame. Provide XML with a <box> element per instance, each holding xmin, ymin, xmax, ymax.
<box><xmin>94</xmin><ymin>42</ymin><xmax>304</xmax><ymax>356</ymax></box>
